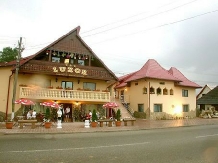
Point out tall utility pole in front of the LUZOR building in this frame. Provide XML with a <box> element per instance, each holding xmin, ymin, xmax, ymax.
<box><xmin>11</xmin><ymin>37</ymin><xmax>23</xmax><ymax>119</ymax></box>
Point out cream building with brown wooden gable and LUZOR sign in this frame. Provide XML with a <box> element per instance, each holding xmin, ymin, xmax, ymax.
<box><xmin>0</xmin><ymin>27</ymin><xmax>118</xmax><ymax>120</ymax></box>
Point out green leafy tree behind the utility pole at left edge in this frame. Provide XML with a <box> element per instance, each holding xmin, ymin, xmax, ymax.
<box><xmin>0</xmin><ymin>47</ymin><xmax>18</xmax><ymax>62</ymax></box>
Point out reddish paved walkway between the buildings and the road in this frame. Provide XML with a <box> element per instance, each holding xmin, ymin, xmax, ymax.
<box><xmin>0</xmin><ymin>118</ymin><xmax>218</xmax><ymax>134</ymax></box>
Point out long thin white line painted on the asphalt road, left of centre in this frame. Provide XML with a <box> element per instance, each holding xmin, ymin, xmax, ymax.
<box><xmin>0</xmin><ymin>142</ymin><xmax>150</xmax><ymax>154</ymax></box>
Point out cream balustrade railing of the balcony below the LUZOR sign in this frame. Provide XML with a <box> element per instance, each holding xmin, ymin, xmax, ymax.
<box><xmin>19</xmin><ymin>87</ymin><xmax>110</xmax><ymax>102</ymax></box>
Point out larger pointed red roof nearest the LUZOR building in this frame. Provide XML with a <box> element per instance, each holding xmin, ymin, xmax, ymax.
<box><xmin>126</xmin><ymin>59</ymin><xmax>181</xmax><ymax>82</ymax></box>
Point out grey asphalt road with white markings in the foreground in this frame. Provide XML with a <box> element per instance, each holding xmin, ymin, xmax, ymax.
<box><xmin>0</xmin><ymin>125</ymin><xmax>218</xmax><ymax>163</ymax></box>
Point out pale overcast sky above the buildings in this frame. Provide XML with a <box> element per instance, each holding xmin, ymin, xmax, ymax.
<box><xmin>0</xmin><ymin>0</ymin><xmax>218</xmax><ymax>88</ymax></box>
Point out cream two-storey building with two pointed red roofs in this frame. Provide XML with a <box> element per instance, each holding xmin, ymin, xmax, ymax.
<box><xmin>115</xmin><ymin>59</ymin><xmax>201</xmax><ymax>119</ymax></box>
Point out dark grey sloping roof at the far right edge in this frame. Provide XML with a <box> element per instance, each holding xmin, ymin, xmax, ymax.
<box><xmin>197</xmin><ymin>86</ymin><xmax>218</xmax><ymax>105</ymax></box>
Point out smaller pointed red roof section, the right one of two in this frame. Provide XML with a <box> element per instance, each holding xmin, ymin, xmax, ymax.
<box><xmin>169</xmin><ymin>67</ymin><xmax>202</xmax><ymax>88</ymax></box>
